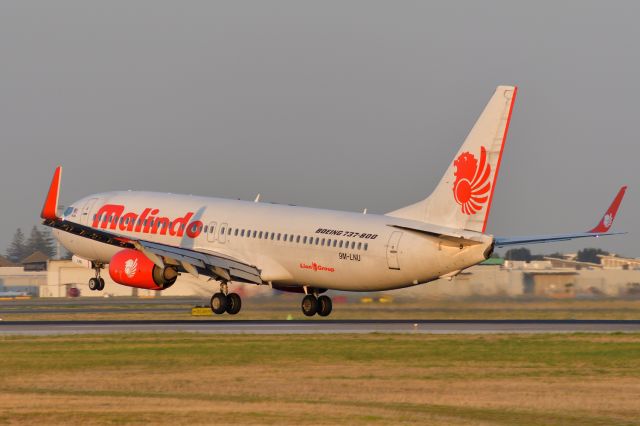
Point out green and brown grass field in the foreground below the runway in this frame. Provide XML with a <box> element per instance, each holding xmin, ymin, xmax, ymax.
<box><xmin>0</xmin><ymin>334</ymin><xmax>640</xmax><ymax>425</ymax></box>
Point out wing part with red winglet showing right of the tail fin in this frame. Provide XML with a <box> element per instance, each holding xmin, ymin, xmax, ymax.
<box><xmin>494</xmin><ymin>186</ymin><xmax>627</xmax><ymax>247</ymax></box>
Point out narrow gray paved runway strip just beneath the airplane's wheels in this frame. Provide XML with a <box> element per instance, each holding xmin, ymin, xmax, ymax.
<box><xmin>0</xmin><ymin>320</ymin><xmax>640</xmax><ymax>336</ymax></box>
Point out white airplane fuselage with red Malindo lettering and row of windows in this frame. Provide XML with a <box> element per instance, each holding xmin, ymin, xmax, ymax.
<box><xmin>54</xmin><ymin>191</ymin><xmax>493</xmax><ymax>291</ymax></box>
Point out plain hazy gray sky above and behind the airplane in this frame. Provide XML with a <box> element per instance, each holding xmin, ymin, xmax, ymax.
<box><xmin>0</xmin><ymin>0</ymin><xmax>640</xmax><ymax>256</ymax></box>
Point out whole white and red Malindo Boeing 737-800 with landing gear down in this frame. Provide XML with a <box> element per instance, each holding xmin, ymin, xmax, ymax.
<box><xmin>41</xmin><ymin>86</ymin><xmax>626</xmax><ymax>317</ymax></box>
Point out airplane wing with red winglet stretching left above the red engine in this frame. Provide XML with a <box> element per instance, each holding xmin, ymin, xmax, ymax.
<box><xmin>40</xmin><ymin>167</ymin><xmax>262</xmax><ymax>284</ymax></box>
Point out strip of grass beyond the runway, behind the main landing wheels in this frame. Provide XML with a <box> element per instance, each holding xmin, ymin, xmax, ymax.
<box><xmin>0</xmin><ymin>295</ymin><xmax>640</xmax><ymax>321</ymax></box>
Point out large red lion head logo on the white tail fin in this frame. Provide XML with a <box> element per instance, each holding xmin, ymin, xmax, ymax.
<box><xmin>453</xmin><ymin>146</ymin><xmax>491</xmax><ymax>215</ymax></box>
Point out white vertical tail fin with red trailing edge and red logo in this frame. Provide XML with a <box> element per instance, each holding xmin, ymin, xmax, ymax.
<box><xmin>387</xmin><ymin>86</ymin><xmax>518</xmax><ymax>232</ymax></box>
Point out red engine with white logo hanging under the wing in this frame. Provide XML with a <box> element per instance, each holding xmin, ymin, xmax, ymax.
<box><xmin>109</xmin><ymin>249</ymin><xmax>178</xmax><ymax>290</ymax></box>
